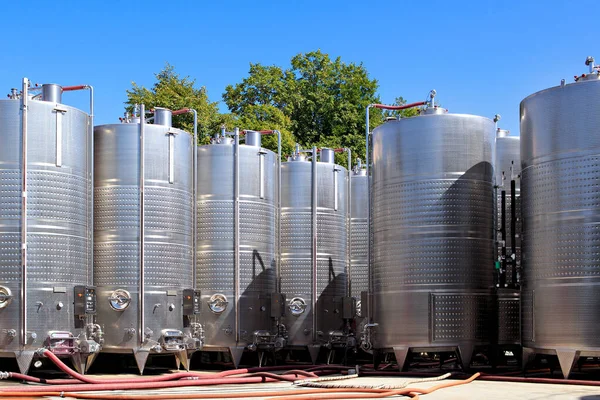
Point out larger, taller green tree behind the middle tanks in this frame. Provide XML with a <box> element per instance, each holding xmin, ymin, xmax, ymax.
<box><xmin>223</xmin><ymin>50</ymin><xmax>383</xmax><ymax>165</ymax></box>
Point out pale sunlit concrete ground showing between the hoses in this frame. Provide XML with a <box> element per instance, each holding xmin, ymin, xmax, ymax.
<box><xmin>0</xmin><ymin>375</ymin><xmax>600</xmax><ymax>400</ymax></box>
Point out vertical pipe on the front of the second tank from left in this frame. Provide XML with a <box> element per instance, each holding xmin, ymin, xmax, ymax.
<box><xmin>138</xmin><ymin>104</ymin><xmax>146</xmax><ymax>344</ymax></box>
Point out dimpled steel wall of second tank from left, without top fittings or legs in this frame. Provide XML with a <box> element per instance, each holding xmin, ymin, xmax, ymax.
<box><xmin>94</xmin><ymin>123</ymin><xmax>194</xmax><ymax>352</ymax></box>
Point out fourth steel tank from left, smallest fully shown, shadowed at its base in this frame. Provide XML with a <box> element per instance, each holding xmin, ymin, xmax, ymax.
<box><xmin>281</xmin><ymin>149</ymin><xmax>349</xmax><ymax>356</ymax></box>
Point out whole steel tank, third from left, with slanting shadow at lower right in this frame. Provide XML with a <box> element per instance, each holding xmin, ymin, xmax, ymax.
<box><xmin>196</xmin><ymin>132</ymin><xmax>278</xmax><ymax>363</ymax></box>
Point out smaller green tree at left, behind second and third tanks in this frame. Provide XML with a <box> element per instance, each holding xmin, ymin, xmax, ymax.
<box><xmin>125</xmin><ymin>63</ymin><xmax>235</xmax><ymax>144</ymax></box>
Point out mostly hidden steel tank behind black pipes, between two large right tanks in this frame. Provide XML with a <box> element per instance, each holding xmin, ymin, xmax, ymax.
<box><xmin>495</xmin><ymin>128</ymin><xmax>521</xmax><ymax>344</ymax></box>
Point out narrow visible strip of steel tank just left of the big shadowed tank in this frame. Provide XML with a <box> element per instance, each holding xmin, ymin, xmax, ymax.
<box><xmin>350</xmin><ymin>169</ymin><xmax>369</xmax><ymax>298</ymax></box>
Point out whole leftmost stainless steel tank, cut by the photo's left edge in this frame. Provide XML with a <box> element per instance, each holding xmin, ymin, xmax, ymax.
<box><xmin>0</xmin><ymin>79</ymin><xmax>101</xmax><ymax>372</ymax></box>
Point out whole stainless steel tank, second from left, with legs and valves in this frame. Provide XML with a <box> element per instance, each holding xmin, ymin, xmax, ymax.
<box><xmin>94</xmin><ymin>106</ymin><xmax>200</xmax><ymax>371</ymax></box>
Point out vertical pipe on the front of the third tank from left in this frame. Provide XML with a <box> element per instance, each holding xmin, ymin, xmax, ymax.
<box><xmin>233</xmin><ymin>128</ymin><xmax>240</xmax><ymax>343</ymax></box>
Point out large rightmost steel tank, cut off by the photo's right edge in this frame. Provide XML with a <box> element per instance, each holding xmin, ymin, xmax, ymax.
<box><xmin>521</xmin><ymin>57</ymin><xmax>600</xmax><ymax>377</ymax></box>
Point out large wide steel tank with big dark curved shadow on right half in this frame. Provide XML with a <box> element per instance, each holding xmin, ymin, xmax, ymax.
<box><xmin>372</xmin><ymin>107</ymin><xmax>495</xmax><ymax>366</ymax></box>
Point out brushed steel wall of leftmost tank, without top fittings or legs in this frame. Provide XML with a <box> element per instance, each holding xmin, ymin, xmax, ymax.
<box><xmin>0</xmin><ymin>99</ymin><xmax>92</xmax><ymax>353</ymax></box>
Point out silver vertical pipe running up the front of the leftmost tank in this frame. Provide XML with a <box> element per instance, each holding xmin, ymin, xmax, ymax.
<box><xmin>21</xmin><ymin>78</ymin><xmax>29</xmax><ymax>346</ymax></box>
